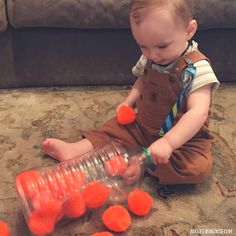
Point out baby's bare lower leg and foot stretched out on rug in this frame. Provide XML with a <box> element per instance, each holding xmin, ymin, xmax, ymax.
<box><xmin>42</xmin><ymin>138</ymin><xmax>93</xmax><ymax>161</ymax></box>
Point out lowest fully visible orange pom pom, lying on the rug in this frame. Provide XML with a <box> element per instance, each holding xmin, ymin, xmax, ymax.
<box><xmin>102</xmin><ymin>205</ymin><xmax>131</xmax><ymax>232</ymax></box>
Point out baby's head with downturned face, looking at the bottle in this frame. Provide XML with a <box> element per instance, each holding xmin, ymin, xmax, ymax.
<box><xmin>130</xmin><ymin>0</ymin><xmax>197</xmax><ymax>65</ymax></box>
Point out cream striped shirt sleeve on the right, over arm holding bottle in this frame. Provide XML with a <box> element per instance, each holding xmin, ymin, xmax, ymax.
<box><xmin>187</xmin><ymin>60</ymin><xmax>220</xmax><ymax>94</ymax></box>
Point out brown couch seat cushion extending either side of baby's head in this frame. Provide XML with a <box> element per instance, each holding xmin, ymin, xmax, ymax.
<box><xmin>6</xmin><ymin>0</ymin><xmax>236</xmax><ymax>29</ymax></box>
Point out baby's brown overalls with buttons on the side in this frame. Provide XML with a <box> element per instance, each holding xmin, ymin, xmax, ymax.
<box><xmin>84</xmin><ymin>51</ymin><xmax>212</xmax><ymax>184</ymax></box>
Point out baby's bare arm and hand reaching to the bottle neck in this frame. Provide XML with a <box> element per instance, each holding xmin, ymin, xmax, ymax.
<box><xmin>148</xmin><ymin>85</ymin><xmax>211</xmax><ymax>164</ymax></box>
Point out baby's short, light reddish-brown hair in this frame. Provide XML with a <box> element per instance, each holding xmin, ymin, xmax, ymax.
<box><xmin>130</xmin><ymin>0</ymin><xmax>193</xmax><ymax>24</ymax></box>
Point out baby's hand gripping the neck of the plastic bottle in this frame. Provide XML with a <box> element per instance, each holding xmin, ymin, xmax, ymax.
<box><xmin>148</xmin><ymin>138</ymin><xmax>173</xmax><ymax>165</ymax></box>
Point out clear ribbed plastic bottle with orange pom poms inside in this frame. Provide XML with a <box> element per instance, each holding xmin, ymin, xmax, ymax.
<box><xmin>15</xmin><ymin>142</ymin><xmax>153</xmax><ymax>235</ymax></box>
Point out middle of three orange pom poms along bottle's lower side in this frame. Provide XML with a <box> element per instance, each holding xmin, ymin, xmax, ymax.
<box><xmin>62</xmin><ymin>193</ymin><xmax>86</xmax><ymax>217</ymax></box>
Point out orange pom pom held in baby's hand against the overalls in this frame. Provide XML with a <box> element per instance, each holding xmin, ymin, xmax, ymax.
<box><xmin>117</xmin><ymin>106</ymin><xmax>135</xmax><ymax>125</ymax></box>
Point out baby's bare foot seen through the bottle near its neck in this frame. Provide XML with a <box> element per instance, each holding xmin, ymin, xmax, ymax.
<box><xmin>123</xmin><ymin>156</ymin><xmax>142</xmax><ymax>184</ymax></box>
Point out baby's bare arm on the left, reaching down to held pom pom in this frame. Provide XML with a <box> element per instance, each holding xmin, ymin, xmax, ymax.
<box><xmin>117</xmin><ymin>76</ymin><xmax>142</xmax><ymax>110</ymax></box>
